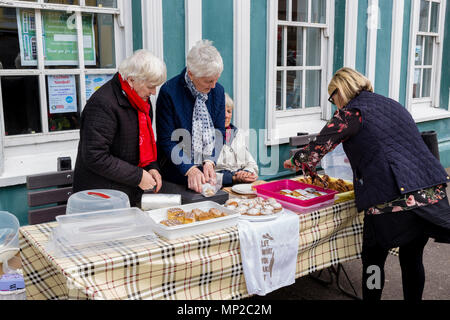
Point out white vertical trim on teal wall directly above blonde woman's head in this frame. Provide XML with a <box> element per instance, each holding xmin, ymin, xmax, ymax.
<box><xmin>344</xmin><ymin>0</ymin><xmax>358</xmax><ymax>69</ymax></box>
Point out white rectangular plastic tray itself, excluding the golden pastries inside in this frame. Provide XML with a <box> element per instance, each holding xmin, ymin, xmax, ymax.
<box><xmin>147</xmin><ymin>201</ymin><xmax>241</xmax><ymax>239</ymax></box>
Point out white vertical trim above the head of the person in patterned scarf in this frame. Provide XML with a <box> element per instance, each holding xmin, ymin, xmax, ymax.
<box><xmin>184</xmin><ymin>0</ymin><xmax>202</xmax><ymax>56</ymax></box>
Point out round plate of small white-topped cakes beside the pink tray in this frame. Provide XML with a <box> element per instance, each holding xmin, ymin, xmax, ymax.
<box><xmin>225</xmin><ymin>197</ymin><xmax>283</xmax><ymax>216</ymax></box>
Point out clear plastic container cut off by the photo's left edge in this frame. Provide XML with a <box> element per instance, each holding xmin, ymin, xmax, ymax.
<box><xmin>0</xmin><ymin>211</ymin><xmax>20</xmax><ymax>273</ymax></box>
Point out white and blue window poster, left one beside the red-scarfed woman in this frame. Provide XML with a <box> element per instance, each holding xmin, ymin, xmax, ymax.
<box><xmin>47</xmin><ymin>75</ymin><xmax>77</xmax><ymax>114</ymax></box>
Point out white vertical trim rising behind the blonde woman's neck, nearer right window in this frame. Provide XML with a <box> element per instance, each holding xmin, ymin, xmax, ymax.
<box><xmin>366</xmin><ymin>0</ymin><xmax>380</xmax><ymax>88</ymax></box>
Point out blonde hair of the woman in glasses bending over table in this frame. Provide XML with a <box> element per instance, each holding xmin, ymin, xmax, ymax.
<box><xmin>328</xmin><ymin>67</ymin><xmax>373</xmax><ymax>106</ymax></box>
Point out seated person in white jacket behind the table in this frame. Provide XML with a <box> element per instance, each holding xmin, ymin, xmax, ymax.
<box><xmin>215</xmin><ymin>93</ymin><xmax>258</xmax><ymax>187</ymax></box>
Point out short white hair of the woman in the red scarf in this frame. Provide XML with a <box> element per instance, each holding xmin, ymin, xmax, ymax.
<box><xmin>119</xmin><ymin>49</ymin><xmax>167</xmax><ymax>86</ymax></box>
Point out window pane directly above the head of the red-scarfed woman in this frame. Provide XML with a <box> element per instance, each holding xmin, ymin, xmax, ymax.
<box><xmin>83</xmin><ymin>13</ymin><xmax>116</xmax><ymax>68</ymax></box>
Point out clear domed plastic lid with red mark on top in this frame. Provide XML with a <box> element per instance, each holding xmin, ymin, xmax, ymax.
<box><xmin>66</xmin><ymin>189</ymin><xmax>130</xmax><ymax>214</ymax></box>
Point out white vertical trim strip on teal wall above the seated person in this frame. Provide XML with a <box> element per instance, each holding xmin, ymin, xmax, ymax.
<box><xmin>233</xmin><ymin>0</ymin><xmax>250</xmax><ymax>134</ymax></box>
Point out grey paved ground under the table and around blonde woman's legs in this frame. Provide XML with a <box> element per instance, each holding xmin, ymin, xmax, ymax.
<box><xmin>250</xmin><ymin>168</ymin><xmax>450</xmax><ymax>300</ymax></box>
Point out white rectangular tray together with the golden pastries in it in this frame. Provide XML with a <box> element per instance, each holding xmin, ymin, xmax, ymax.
<box><xmin>146</xmin><ymin>201</ymin><xmax>239</xmax><ymax>239</ymax></box>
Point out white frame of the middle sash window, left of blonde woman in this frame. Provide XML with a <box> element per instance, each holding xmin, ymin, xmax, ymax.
<box><xmin>265</xmin><ymin>0</ymin><xmax>335</xmax><ymax>145</ymax></box>
